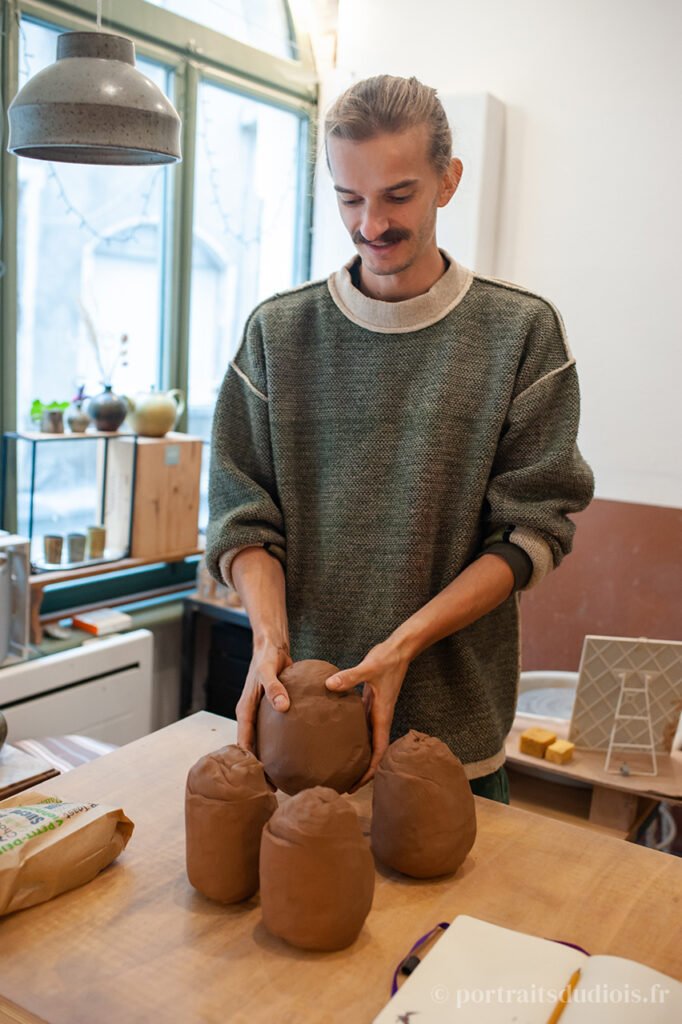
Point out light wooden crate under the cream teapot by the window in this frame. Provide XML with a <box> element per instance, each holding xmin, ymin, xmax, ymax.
<box><xmin>105</xmin><ymin>433</ymin><xmax>204</xmax><ymax>558</ymax></box>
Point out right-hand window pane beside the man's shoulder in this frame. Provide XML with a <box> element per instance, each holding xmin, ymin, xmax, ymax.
<box><xmin>188</xmin><ymin>82</ymin><xmax>302</xmax><ymax>439</ymax></box>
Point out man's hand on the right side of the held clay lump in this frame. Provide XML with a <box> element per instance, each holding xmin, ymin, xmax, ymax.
<box><xmin>326</xmin><ymin>638</ymin><xmax>410</xmax><ymax>790</ymax></box>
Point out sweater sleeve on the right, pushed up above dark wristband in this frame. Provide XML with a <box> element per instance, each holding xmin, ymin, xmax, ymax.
<box><xmin>483</xmin><ymin>302</ymin><xmax>594</xmax><ymax>588</ymax></box>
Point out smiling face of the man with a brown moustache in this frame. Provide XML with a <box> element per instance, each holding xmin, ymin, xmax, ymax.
<box><xmin>327</xmin><ymin>125</ymin><xmax>462</xmax><ymax>290</ymax></box>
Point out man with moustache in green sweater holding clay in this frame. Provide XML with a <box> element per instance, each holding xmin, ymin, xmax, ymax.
<box><xmin>207</xmin><ymin>76</ymin><xmax>593</xmax><ymax>801</ymax></box>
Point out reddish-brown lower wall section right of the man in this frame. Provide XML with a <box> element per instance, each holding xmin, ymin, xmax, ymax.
<box><xmin>521</xmin><ymin>500</ymin><xmax>682</xmax><ymax>671</ymax></box>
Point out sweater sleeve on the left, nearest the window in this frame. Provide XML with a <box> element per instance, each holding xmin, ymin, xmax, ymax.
<box><xmin>206</xmin><ymin>315</ymin><xmax>286</xmax><ymax>583</ymax></box>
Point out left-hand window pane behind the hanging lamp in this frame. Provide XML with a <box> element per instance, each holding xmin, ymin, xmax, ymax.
<box><xmin>16</xmin><ymin>19</ymin><xmax>172</xmax><ymax>428</ymax></box>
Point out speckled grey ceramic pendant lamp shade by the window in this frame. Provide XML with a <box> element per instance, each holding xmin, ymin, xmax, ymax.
<box><xmin>7</xmin><ymin>32</ymin><xmax>180</xmax><ymax>164</ymax></box>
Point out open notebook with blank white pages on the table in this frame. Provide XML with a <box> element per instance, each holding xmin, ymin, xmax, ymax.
<box><xmin>374</xmin><ymin>914</ymin><xmax>682</xmax><ymax>1024</ymax></box>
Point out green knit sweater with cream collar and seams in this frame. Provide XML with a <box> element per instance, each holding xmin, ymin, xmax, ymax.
<box><xmin>206</xmin><ymin>253</ymin><xmax>593</xmax><ymax>778</ymax></box>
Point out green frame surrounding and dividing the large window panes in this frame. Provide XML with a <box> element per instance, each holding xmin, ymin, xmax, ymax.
<box><xmin>0</xmin><ymin>0</ymin><xmax>317</xmax><ymax>607</ymax></box>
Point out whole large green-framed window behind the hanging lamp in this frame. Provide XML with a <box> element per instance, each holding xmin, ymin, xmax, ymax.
<box><xmin>0</xmin><ymin>0</ymin><xmax>316</xmax><ymax>585</ymax></box>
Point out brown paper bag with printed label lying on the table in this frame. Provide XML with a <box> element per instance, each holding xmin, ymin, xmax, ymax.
<box><xmin>0</xmin><ymin>793</ymin><xmax>134</xmax><ymax>915</ymax></box>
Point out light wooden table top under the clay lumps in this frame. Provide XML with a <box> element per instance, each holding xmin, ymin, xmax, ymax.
<box><xmin>0</xmin><ymin>712</ymin><xmax>682</xmax><ymax>1024</ymax></box>
